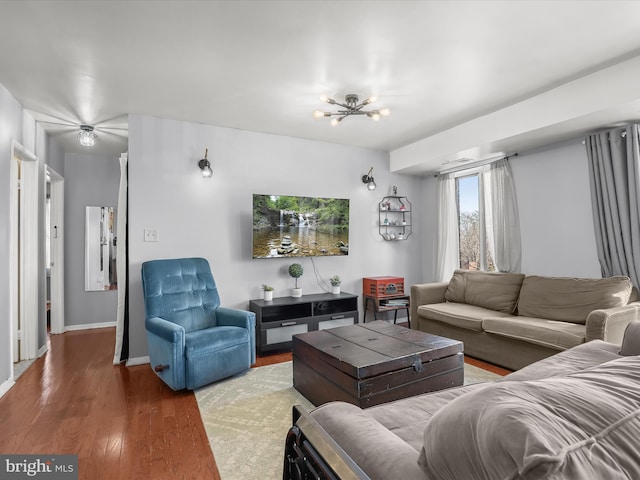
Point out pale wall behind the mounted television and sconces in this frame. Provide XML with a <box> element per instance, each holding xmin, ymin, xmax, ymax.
<box><xmin>129</xmin><ymin>115</ymin><xmax>421</xmax><ymax>358</ymax></box>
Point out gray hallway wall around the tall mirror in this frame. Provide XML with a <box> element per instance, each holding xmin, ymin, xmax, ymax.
<box><xmin>64</xmin><ymin>153</ymin><xmax>120</xmax><ymax>328</ymax></box>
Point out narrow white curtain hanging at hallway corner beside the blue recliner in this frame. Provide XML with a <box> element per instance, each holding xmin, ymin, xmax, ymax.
<box><xmin>113</xmin><ymin>153</ymin><xmax>129</xmax><ymax>365</ymax></box>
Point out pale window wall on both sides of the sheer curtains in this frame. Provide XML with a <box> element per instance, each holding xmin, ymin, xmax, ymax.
<box><xmin>422</xmin><ymin>138</ymin><xmax>602</xmax><ymax>282</ymax></box>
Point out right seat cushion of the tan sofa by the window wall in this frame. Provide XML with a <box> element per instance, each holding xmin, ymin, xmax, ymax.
<box><xmin>482</xmin><ymin>317</ymin><xmax>587</xmax><ymax>350</ymax></box>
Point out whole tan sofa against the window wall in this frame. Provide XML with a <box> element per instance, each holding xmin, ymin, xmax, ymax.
<box><xmin>411</xmin><ymin>270</ymin><xmax>640</xmax><ymax>370</ymax></box>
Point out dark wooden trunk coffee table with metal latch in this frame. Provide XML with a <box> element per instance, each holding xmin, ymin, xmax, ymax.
<box><xmin>292</xmin><ymin>320</ymin><xmax>464</xmax><ymax>408</ymax></box>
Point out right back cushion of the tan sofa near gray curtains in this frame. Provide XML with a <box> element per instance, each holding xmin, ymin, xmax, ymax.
<box><xmin>518</xmin><ymin>275</ymin><xmax>632</xmax><ymax>323</ymax></box>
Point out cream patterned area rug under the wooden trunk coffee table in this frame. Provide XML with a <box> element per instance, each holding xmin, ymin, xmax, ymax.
<box><xmin>195</xmin><ymin>362</ymin><xmax>499</xmax><ymax>480</ymax></box>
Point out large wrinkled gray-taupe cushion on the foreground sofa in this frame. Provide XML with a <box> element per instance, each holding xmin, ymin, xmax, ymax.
<box><xmin>418</xmin><ymin>356</ymin><xmax>640</xmax><ymax>480</ymax></box>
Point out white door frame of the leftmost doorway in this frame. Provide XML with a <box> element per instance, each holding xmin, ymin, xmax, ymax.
<box><xmin>9</xmin><ymin>139</ymin><xmax>44</xmax><ymax>366</ymax></box>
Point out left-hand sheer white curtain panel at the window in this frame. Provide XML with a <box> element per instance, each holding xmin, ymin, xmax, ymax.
<box><xmin>436</xmin><ymin>173</ymin><xmax>460</xmax><ymax>282</ymax></box>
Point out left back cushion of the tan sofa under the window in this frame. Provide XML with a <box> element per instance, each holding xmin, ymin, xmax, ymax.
<box><xmin>445</xmin><ymin>269</ymin><xmax>524</xmax><ymax>313</ymax></box>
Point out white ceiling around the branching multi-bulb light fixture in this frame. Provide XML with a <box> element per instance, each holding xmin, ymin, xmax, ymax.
<box><xmin>0</xmin><ymin>0</ymin><xmax>640</xmax><ymax>173</ymax></box>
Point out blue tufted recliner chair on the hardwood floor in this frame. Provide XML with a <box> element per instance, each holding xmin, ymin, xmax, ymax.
<box><xmin>142</xmin><ymin>258</ymin><xmax>256</xmax><ymax>390</ymax></box>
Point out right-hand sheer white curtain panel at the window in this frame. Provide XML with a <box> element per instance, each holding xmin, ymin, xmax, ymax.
<box><xmin>480</xmin><ymin>158</ymin><xmax>522</xmax><ymax>272</ymax></box>
